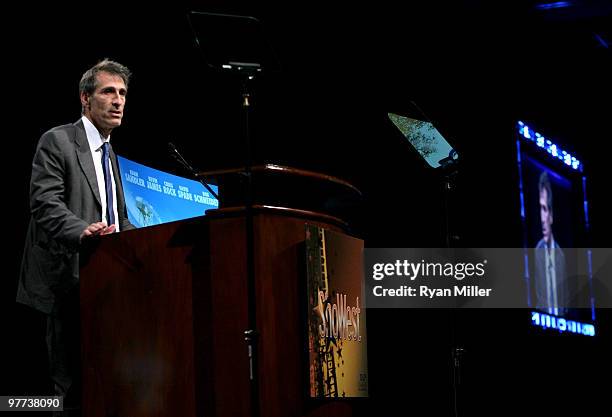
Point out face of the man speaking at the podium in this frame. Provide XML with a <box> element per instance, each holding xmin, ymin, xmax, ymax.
<box><xmin>81</xmin><ymin>72</ymin><xmax>127</xmax><ymax>136</ymax></box>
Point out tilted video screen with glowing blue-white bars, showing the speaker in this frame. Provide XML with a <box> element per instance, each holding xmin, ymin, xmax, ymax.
<box><xmin>517</xmin><ymin>122</ymin><xmax>595</xmax><ymax>334</ymax></box>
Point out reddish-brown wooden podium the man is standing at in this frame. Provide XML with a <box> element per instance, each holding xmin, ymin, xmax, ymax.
<box><xmin>80</xmin><ymin>167</ymin><xmax>358</xmax><ymax>417</ymax></box>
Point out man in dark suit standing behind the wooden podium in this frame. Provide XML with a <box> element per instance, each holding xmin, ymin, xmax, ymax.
<box><xmin>17</xmin><ymin>59</ymin><xmax>134</xmax><ymax>408</ymax></box>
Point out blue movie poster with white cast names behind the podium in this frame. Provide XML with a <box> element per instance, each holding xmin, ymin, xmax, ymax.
<box><xmin>117</xmin><ymin>156</ymin><xmax>219</xmax><ymax>227</ymax></box>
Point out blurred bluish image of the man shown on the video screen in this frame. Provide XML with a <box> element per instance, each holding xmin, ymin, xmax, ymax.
<box><xmin>534</xmin><ymin>171</ymin><xmax>568</xmax><ymax>315</ymax></box>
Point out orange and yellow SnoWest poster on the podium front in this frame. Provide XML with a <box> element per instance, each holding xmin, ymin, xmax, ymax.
<box><xmin>306</xmin><ymin>225</ymin><xmax>368</xmax><ymax>398</ymax></box>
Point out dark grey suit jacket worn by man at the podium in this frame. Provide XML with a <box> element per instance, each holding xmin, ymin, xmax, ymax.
<box><xmin>17</xmin><ymin>120</ymin><xmax>134</xmax><ymax>314</ymax></box>
